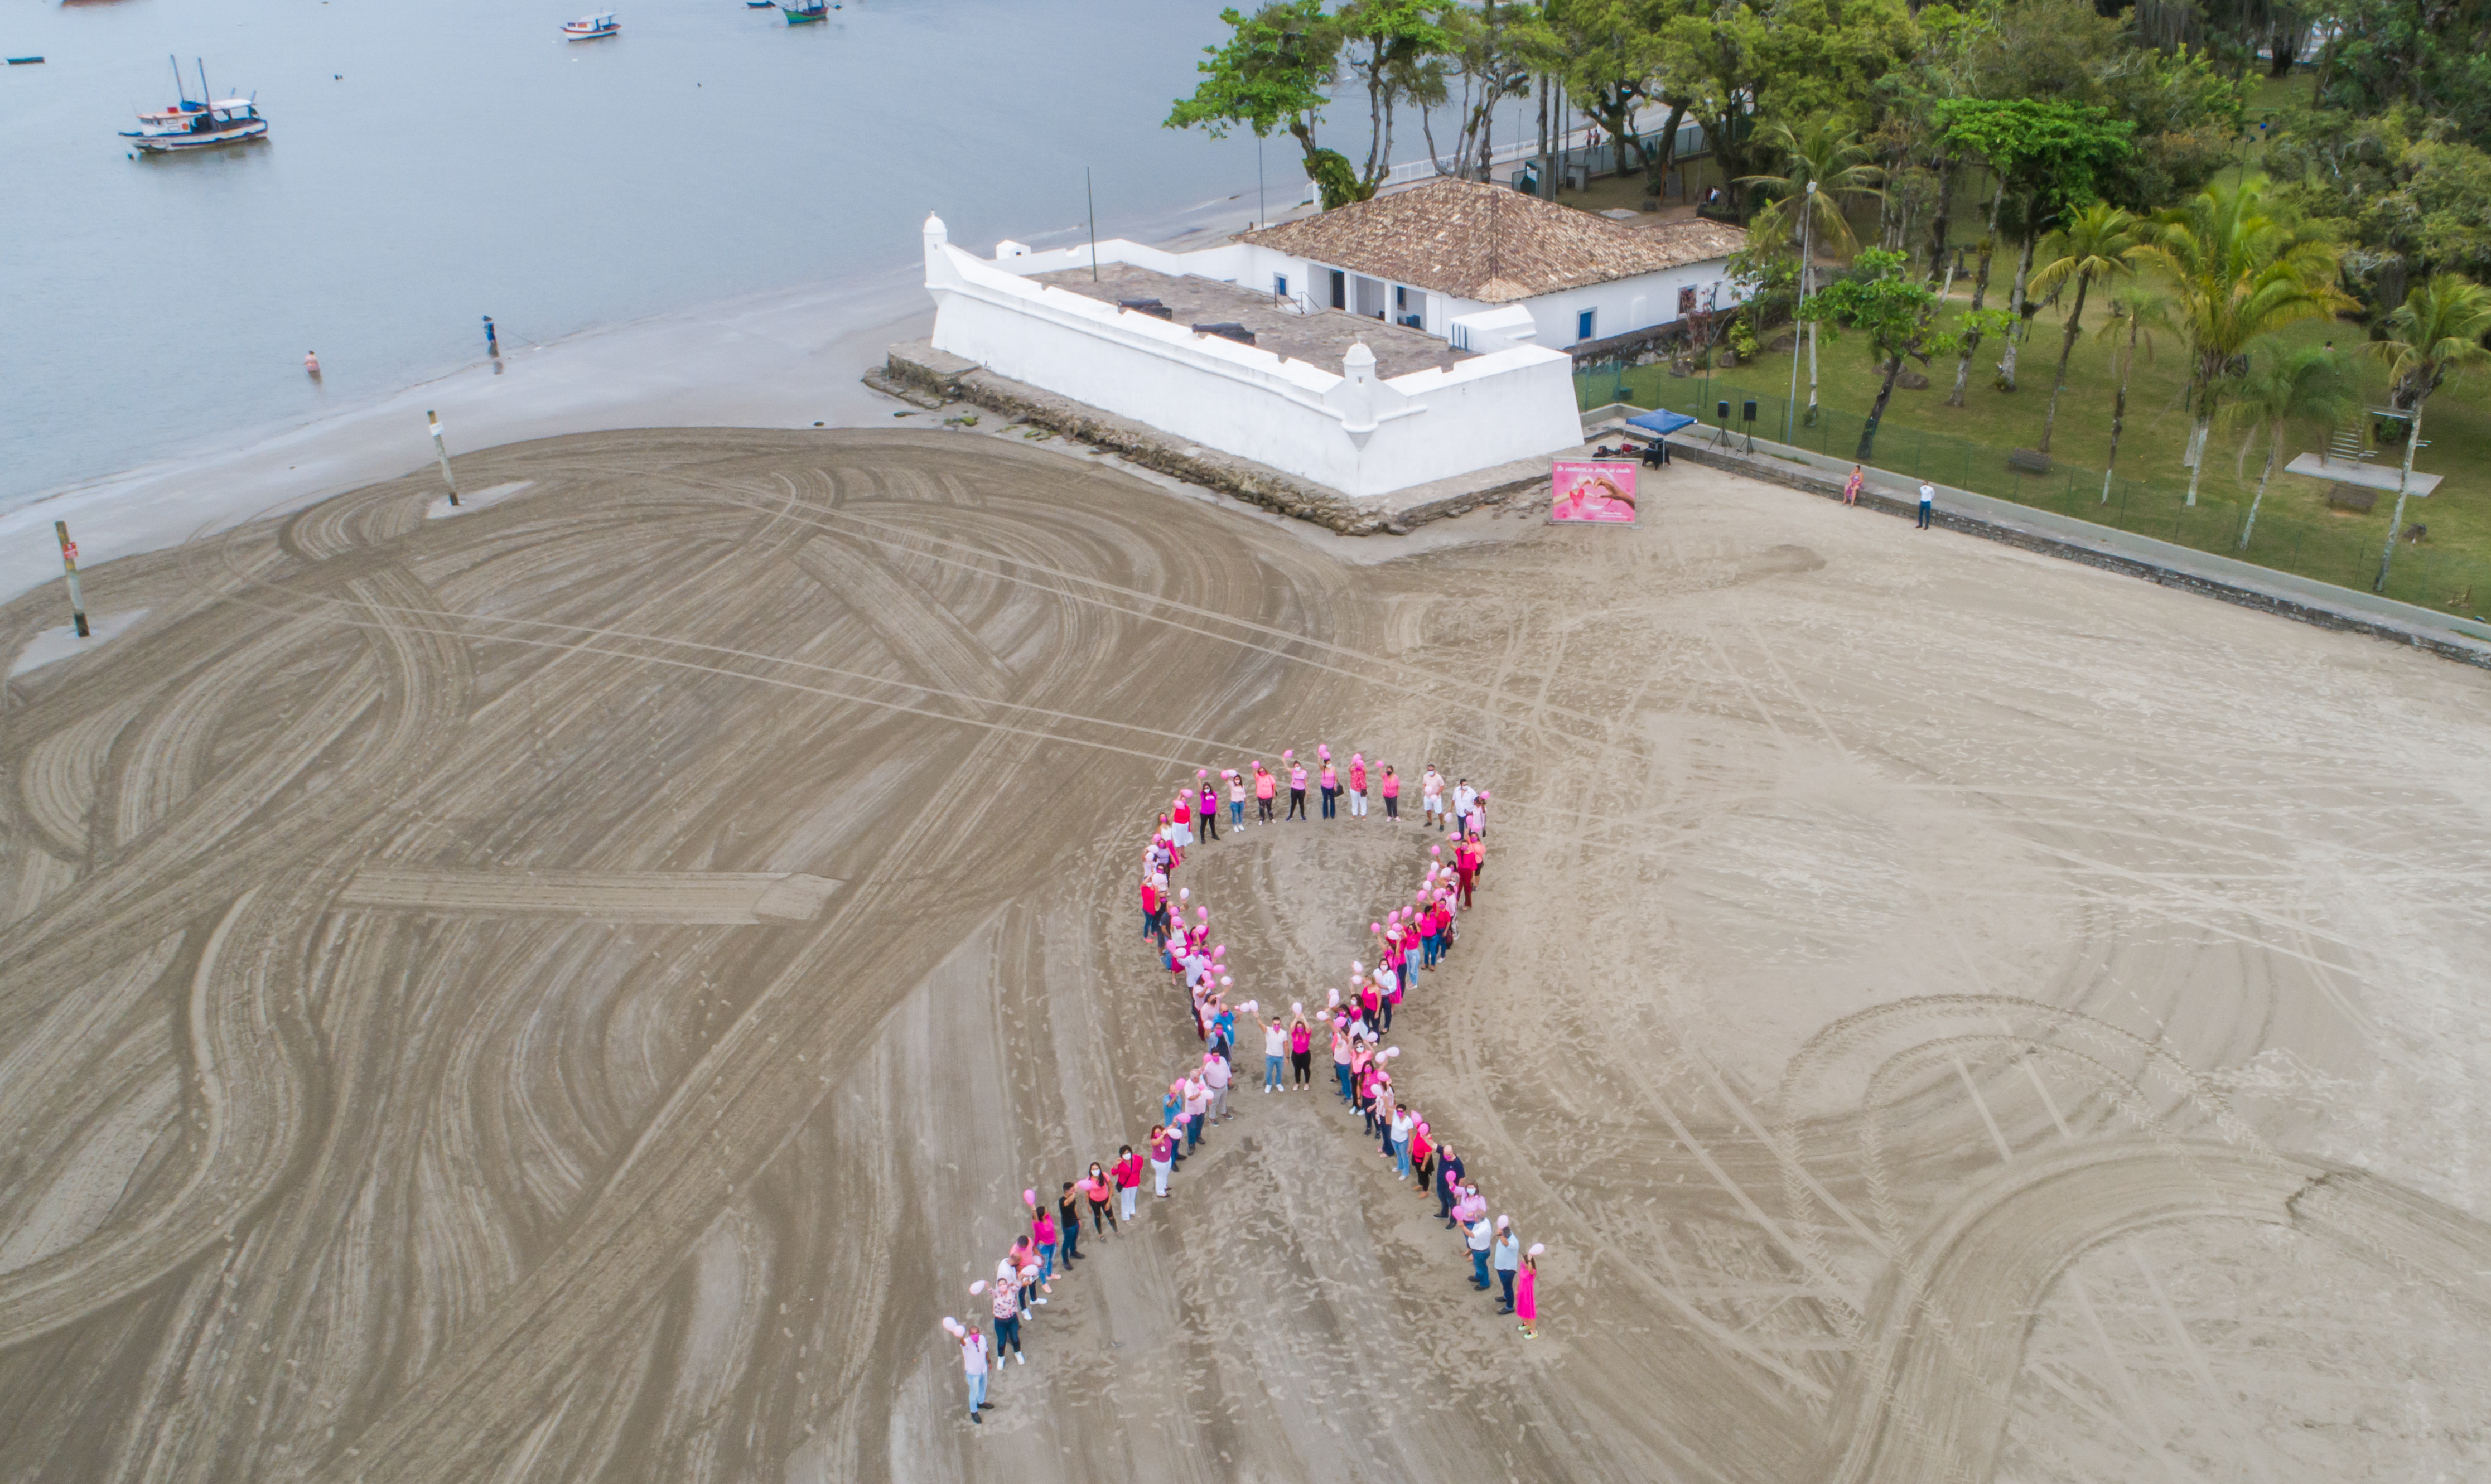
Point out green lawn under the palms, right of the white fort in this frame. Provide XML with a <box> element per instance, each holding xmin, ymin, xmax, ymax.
<box><xmin>1577</xmin><ymin>283</ymin><xmax>2491</xmax><ymax>615</ymax></box>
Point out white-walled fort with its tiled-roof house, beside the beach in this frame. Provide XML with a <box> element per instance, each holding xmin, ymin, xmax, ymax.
<box><xmin>892</xmin><ymin>179</ymin><xmax>1744</xmax><ymax>518</ymax></box>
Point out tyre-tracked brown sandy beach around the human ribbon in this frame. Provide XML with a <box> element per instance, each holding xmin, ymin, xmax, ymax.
<box><xmin>0</xmin><ymin>423</ymin><xmax>2491</xmax><ymax>1484</ymax></box>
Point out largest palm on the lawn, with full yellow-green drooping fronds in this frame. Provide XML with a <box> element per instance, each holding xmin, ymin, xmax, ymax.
<box><xmin>2137</xmin><ymin>179</ymin><xmax>2352</xmax><ymax>505</ymax></box>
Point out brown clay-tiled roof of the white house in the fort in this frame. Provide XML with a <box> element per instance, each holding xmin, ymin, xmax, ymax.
<box><xmin>1243</xmin><ymin>177</ymin><xmax>1746</xmax><ymax>304</ymax></box>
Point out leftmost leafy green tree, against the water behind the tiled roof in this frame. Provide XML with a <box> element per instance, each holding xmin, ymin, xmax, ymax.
<box><xmin>1164</xmin><ymin>0</ymin><xmax>1375</xmax><ymax>212</ymax></box>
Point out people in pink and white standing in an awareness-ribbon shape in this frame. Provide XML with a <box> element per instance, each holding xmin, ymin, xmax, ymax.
<box><xmin>944</xmin><ymin>745</ymin><xmax>1542</xmax><ymax>1422</ymax></box>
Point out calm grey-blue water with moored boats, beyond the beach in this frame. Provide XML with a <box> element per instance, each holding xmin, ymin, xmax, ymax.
<box><xmin>0</xmin><ymin>0</ymin><xmax>1305</xmax><ymax>510</ymax></box>
